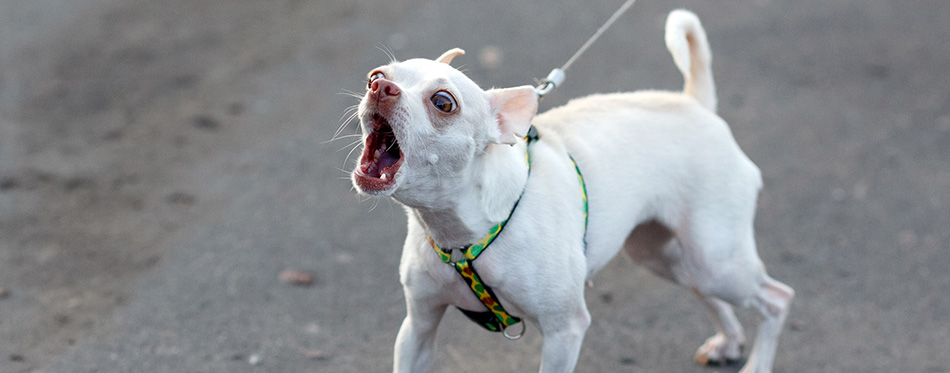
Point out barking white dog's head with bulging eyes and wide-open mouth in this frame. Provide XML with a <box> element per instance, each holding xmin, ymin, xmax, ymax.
<box><xmin>352</xmin><ymin>48</ymin><xmax>538</xmax><ymax>206</ymax></box>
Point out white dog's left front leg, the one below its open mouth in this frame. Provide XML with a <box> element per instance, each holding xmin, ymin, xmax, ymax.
<box><xmin>393</xmin><ymin>291</ymin><xmax>446</xmax><ymax>372</ymax></box>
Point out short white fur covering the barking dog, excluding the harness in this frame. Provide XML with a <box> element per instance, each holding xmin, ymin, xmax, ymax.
<box><xmin>353</xmin><ymin>10</ymin><xmax>794</xmax><ymax>372</ymax></box>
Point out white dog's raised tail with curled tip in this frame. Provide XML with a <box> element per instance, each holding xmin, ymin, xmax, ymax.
<box><xmin>666</xmin><ymin>9</ymin><xmax>716</xmax><ymax>112</ymax></box>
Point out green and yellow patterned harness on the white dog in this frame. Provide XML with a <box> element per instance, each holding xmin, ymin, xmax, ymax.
<box><xmin>426</xmin><ymin>126</ymin><xmax>588</xmax><ymax>339</ymax></box>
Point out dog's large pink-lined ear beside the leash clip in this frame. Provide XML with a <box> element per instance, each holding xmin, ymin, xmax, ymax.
<box><xmin>487</xmin><ymin>85</ymin><xmax>538</xmax><ymax>145</ymax></box>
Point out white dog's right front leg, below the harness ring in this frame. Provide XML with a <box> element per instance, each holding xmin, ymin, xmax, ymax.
<box><xmin>539</xmin><ymin>304</ymin><xmax>590</xmax><ymax>373</ymax></box>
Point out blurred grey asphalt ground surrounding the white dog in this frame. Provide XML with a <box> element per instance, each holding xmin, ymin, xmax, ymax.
<box><xmin>0</xmin><ymin>0</ymin><xmax>950</xmax><ymax>372</ymax></box>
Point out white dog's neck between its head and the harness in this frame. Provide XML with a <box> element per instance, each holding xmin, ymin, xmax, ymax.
<box><xmin>409</xmin><ymin>143</ymin><xmax>528</xmax><ymax>248</ymax></box>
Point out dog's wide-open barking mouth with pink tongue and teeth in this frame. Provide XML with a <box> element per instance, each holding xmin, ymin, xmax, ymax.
<box><xmin>355</xmin><ymin>113</ymin><xmax>402</xmax><ymax>192</ymax></box>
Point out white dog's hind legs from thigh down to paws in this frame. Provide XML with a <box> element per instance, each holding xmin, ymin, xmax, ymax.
<box><xmin>675</xmin><ymin>177</ymin><xmax>795</xmax><ymax>373</ymax></box>
